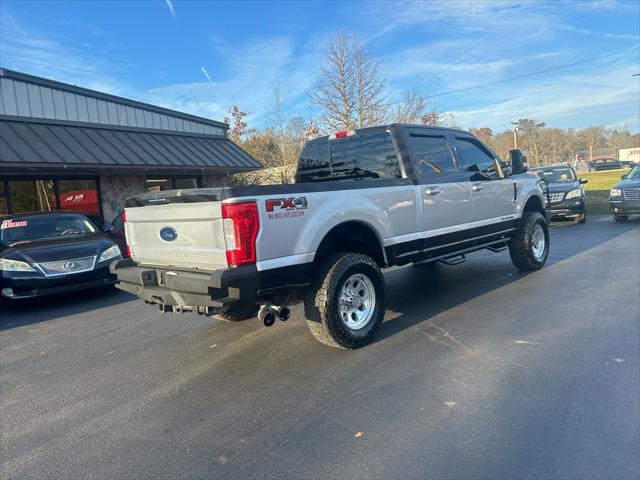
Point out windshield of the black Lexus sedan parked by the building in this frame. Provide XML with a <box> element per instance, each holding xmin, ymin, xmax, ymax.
<box><xmin>0</xmin><ymin>214</ymin><xmax>96</xmax><ymax>244</ymax></box>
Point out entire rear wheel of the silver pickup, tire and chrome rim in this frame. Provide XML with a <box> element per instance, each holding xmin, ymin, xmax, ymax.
<box><xmin>304</xmin><ymin>253</ymin><xmax>385</xmax><ymax>348</ymax></box>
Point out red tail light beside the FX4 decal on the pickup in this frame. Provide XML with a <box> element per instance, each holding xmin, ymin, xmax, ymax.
<box><xmin>222</xmin><ymin>202</ymin><xmax>260</xmax><ymax>267</ymax></box>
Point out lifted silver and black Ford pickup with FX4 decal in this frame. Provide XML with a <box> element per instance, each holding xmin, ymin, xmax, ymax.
<box><xmin>111</xmin><ymin>124</ymin><xmax>549</xmax><ymax>348</ymax></box>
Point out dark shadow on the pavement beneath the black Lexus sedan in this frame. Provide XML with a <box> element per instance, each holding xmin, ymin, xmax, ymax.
<box><xmin>0</xmin><ymin>286</ymin><xmax>135</xmax><ymax>331</ymax></box>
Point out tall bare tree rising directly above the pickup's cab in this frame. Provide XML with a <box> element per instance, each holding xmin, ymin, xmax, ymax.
<box><xmin>310</xmin><ymin>32</ymin><xmax>387</xmax><ymax>131</ymax></box>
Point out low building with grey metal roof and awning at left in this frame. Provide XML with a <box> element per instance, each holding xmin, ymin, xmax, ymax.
<box><xmin>0</xmin><ymin>68</ymin><xmax>261</xmax><ymax>225</ymax></box>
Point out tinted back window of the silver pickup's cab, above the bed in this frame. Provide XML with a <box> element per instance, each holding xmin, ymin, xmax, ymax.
<box><xmin>296</xmin><ymin>130</ymin><xmax>402</xmax><ymax>183</ymax></box>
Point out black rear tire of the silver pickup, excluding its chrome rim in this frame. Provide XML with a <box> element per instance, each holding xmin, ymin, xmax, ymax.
<box><xmin>304</xmin><ymin>253</ymin><xmax>385</xmax><ymax>349</ymax></box>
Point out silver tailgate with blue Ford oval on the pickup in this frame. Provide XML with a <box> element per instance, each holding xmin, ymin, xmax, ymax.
<box><xmin>125</xmin><ymin>201</ymin><xmax>228</xmax><ymax>271</ymax></box>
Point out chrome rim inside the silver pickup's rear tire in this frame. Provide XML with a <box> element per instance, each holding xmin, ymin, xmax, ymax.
<box><xmin>338</xmin><ymin>273</ymin><xmax>376</xmax><ymax>330</ymax></box>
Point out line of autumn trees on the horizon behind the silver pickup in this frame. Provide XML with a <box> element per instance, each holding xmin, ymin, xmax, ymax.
<box><xmin>224</xmin><ymin>32</ymin><xmax>640</xmax><ymax>182</ymax></box>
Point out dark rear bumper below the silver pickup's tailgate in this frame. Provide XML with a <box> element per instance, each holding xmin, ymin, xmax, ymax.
<box><xmin>109</xmin><ymin>258</ymin><xmax>258</xmax><ymax>307</ymax></box>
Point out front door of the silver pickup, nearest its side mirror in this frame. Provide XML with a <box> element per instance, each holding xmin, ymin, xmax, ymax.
<box><xmin>453</xmin><ymin>134</ymin><xmax>517</xmax><ymax>238</ymax></box>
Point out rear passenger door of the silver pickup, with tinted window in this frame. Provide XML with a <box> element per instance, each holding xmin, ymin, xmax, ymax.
<box><xmin>407</xmin><ymin>128</ymin><xmax>471</xmax><ymax>250</ymax></box>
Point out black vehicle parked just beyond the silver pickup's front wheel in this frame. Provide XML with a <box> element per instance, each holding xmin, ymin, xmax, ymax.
<box><xmin>529</xmin><ymin>165</ymin><xmax>588</xmax><ymax>223</ymax></box>
